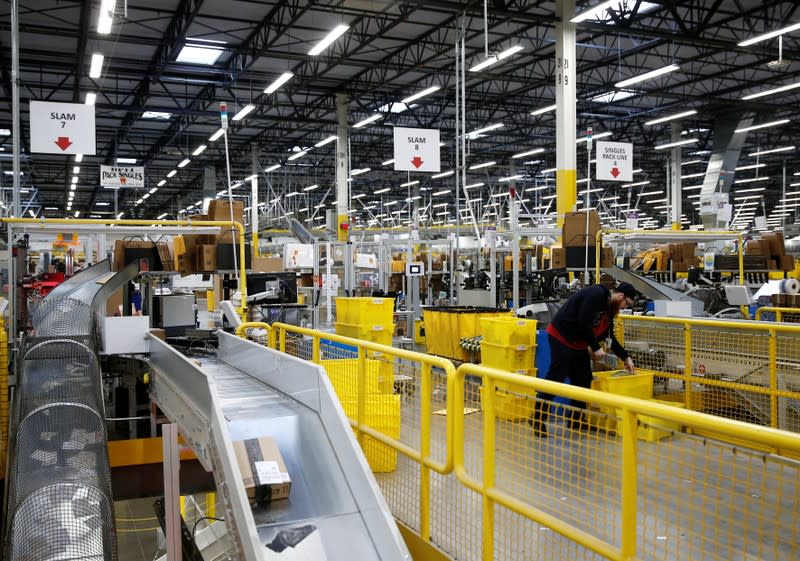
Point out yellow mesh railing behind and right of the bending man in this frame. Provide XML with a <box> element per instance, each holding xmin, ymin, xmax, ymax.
<box><xmin>617</xmin><ymin>315</ymin><xmax>800</xmax><ymax>432</ymax></box>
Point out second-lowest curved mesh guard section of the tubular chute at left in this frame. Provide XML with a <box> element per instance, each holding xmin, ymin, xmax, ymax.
<box><xmin>8</xmin><ymin>403</ymin><xmax>111</xmax><ymax>512</ymax></box>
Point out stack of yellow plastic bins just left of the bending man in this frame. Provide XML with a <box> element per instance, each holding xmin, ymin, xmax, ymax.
<box><xmin>480</xmin><ymin>316</ymin><xmax>536</xmax><ymax>420</ymax></box>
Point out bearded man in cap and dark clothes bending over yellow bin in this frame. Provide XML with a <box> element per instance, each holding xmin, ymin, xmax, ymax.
<box><xmin>530</xmin><ymin>282</ymin><xmax>637</xmax><ymax>437</ymax></box>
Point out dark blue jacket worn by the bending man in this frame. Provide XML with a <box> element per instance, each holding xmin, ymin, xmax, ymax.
<box><xmin>547</xmin><ymin>284</ymin><xmax>628</xmax><ymax>360</ymax></box>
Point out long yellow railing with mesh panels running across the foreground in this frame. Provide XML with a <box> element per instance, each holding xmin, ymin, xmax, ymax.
<box><xmin>241</xmin><ymin>318</ymin><xmax>800</xmax><ymax>561</ymax></box>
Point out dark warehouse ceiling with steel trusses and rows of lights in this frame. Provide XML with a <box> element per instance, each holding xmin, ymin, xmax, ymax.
<box><xmin>0</xmin><ymin>0</ymin><xmax>800</xmax><ymax>232</ymax></box>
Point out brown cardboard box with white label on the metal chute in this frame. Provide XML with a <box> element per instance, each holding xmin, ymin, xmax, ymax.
<box><xmin>233</xmin><ymin>436</ymin><xmax>292</xmax><ymax>504</ymax></box>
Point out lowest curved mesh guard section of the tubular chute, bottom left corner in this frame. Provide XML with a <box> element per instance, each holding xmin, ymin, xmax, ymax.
<box><xmin>5</xmin><ymin>483</ymin><xmax>116</xmax><ymax>561</ymax></box>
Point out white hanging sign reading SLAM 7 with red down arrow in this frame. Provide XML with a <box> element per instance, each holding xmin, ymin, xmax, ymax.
<box><xmin>30</xmin><ymin>101</ymin><xmax>95</xmax><ymax>156</ymax></box>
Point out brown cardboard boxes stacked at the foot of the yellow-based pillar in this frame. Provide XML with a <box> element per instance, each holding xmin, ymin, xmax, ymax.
<box><xmin>550</xmin><ymin>210</ymin><xmax>614</xmax><ymax>269</ymax></box>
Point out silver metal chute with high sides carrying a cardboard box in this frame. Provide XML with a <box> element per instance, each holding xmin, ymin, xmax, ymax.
<box><xmin>151</xmin><ymin>333</ymin><xmax>411</xmax><ymax>561</ymax></box>
